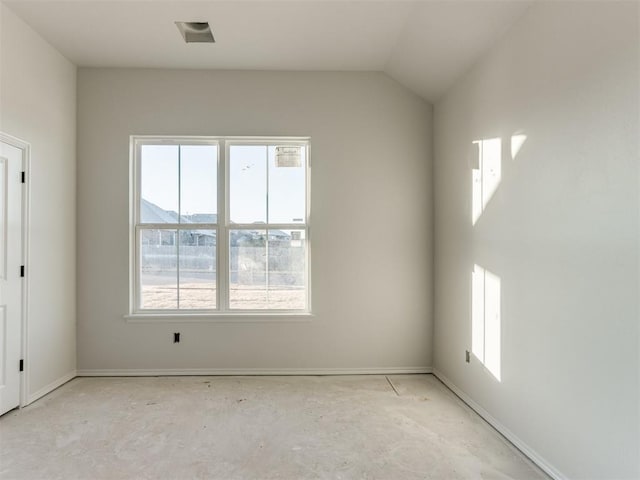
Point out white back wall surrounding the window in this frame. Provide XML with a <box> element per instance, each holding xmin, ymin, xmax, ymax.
<box><xmin>78</xmin><ymin>68</ymin><xmax>432</xmax><ymax>373</ymax></box>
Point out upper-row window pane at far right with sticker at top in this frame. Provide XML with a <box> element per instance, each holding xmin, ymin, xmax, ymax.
<box><xmin>269</xmin><ymin>146</ymin><xmax>306</xmax><ymax>223</ymax></box>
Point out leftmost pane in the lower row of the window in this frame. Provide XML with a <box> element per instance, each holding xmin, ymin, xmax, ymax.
<box><xmin>140</xmin><ymin>229</ymin><xmax>178</xmax><ymax>309</ymax></box>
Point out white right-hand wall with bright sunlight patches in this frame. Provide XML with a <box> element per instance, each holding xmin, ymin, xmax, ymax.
<box><xmin>434</xmin><ymin>2</ymin><xmax>640</xmax><ymax>479</ymax></box>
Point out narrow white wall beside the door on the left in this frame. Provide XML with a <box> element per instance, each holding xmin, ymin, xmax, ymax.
<box><xmin>0</xmin><ymin>5</ymin><xmax>76</xmax><ymax>399</ymax></box>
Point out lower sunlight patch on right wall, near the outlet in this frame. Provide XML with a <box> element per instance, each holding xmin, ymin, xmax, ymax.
<box><xmin>471</xmin><ymin>265</ymin><xmax>502</xmax><ymax>381</ymax></box>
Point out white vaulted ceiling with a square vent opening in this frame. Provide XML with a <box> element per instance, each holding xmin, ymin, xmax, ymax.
<box><xmin>3</xmin><ymin>0</ymin><xmax>532</xmax><ymax>101</ymax></box>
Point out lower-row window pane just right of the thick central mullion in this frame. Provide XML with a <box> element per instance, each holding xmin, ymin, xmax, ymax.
<box><xmin>229</xmin><ymin>230</ymin><xmax>268</xmax><ymax>310</ymax></box>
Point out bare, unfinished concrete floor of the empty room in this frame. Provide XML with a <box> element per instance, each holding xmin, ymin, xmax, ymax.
<box><xmin>0</xmin><ymin>375</ymin><xmax>547</xmax><ymax>480</ymax></box>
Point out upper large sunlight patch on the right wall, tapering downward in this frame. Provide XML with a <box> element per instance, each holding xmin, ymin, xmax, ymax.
<box><xmin>472</xmin><ymin>138</ymin><xmax>502</xmax><ymax>225</ymax></box>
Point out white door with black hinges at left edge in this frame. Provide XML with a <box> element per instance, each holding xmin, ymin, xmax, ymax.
<box><xmin>0</xmin><ymin>141</ymin><xmax>23</xmax><ymax>415</ymax></box>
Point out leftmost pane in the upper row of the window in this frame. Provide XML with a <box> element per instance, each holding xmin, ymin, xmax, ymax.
<box><xmin>140</xmin><ymin>145</ymin><xmax>178</xmax><ymax>223</ymax></box>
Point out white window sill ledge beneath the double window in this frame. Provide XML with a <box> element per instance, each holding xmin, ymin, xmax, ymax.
<box><xmin>123</xmin><ymin>312</ymin><xmax>314</xmax><ymax>324</ymax></box>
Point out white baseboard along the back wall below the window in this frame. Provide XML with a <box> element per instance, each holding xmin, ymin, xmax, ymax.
<box><xmin>77</xmin><ymin>367</ymin><xmax>432</xmax><ymax>377</ymax></box>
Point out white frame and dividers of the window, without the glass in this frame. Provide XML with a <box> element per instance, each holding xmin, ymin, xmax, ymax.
<box><xmin>124</xmin><ymin>135</ymin><xmax>312</xmax><ymax>322</ymax></box>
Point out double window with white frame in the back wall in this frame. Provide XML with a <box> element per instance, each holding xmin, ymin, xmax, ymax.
<box><xmin>131</xmin><ymin>137</ymin><xmax>309</xmax><ymax>315</ymax></box>
